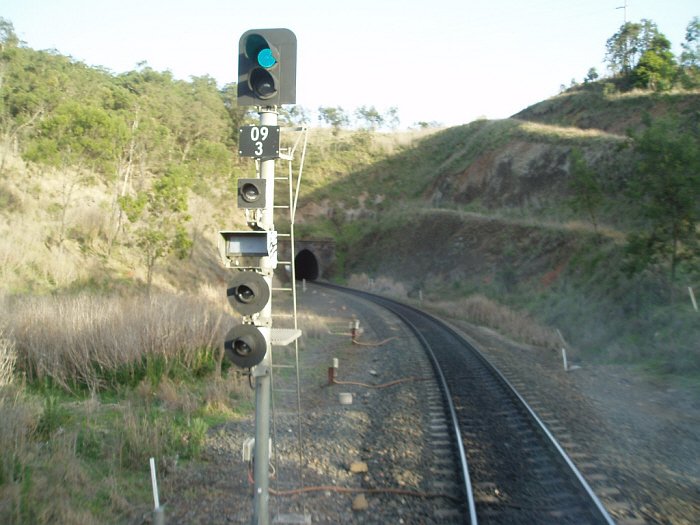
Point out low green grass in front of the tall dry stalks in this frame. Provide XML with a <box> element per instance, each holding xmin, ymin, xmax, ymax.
<box><xmin>0</xmin><ymin>371</ymin><xmax>252</xmax><ymax>524</ymax></box>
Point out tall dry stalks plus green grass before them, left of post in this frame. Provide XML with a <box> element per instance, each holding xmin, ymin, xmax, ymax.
<box><xmin>0</xmin><ymin>288</ymin><xmax>252</xmax><ymax>524</ymax></box>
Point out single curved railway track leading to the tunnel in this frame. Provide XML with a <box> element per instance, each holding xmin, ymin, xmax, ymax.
<box><xmin>317</xmin><ymin>283</ymin><xmax>614</xmax><ymax>525</ymax></box>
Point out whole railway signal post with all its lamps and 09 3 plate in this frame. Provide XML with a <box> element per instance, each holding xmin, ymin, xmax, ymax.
<box><xmin>219</xmin><ymin>28</ymin><xmax>296</xmax><ymax>525</ymax></box>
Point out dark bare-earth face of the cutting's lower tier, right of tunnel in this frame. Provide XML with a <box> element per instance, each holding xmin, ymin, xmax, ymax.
<box><xmin>347</xmin><ymin>210</ymin><xmax>577</xmax><ymax>289</ymax></box>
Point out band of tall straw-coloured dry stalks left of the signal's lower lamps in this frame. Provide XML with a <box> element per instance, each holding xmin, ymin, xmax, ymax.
<box><xmin>2</xmin><ymin>295</ymin><xmax>231</xmax><ymax>390</ymax></box>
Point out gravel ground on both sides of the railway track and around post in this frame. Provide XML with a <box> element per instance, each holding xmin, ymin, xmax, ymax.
<box><xmin>161</xmin><ymin>287</ymin><xmax>700</xmax><ymax>525</ymax></box>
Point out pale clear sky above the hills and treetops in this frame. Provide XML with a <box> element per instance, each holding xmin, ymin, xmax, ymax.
<box><xmin>0</xmin><ymin>0</ymin><xmax>700</xmax><ymax>128</ymax></box>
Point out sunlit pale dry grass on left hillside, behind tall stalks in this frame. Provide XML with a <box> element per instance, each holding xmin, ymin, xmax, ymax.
<box><xmin>0</xmin><ymin>146</ymin><xmax>234</xmax><ymax>294</ymax></box>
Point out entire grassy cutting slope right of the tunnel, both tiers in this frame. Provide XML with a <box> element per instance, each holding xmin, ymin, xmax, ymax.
<box><xmin>302</xmin><ymin>83</ymin><xmax>700</xmax><ymax>382</ymax></box>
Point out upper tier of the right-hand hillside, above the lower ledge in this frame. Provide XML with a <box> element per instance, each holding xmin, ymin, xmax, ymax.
<box><xmin>306</xmin><ymin>83</ymin><xmax>700</xmax><ymax>223</ymax></box>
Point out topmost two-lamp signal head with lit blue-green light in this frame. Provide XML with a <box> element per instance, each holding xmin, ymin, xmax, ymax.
<box><xmin>238</xmin><ymin>28</ymin><xmax>297</xmax><ymax>107</ymax></box>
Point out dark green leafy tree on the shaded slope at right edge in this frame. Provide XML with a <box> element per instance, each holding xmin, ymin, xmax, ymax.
<box><xmin>627</xmin><ymin>118</ymin><xmax>700</xmax><ymax>283</ymax></box>
